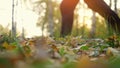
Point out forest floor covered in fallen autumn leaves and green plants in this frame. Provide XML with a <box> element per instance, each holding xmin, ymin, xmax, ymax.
<box><xmin>0</xmin><ymin>35</ymin><xmax>120</xmax><ymax>68</ymax></box>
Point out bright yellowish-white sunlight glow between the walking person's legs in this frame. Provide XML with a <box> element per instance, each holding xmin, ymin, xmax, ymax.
<box><xmin>76</xmin><ymin>0</ymin><xmax>92</xmax><ymax>29</ymax></box>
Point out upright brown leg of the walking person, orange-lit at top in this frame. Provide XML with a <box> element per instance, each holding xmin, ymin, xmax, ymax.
<box><xmin>60</xmin><ymin>0</ymin><xmax>79</xmax><ymax>36</ymax></box>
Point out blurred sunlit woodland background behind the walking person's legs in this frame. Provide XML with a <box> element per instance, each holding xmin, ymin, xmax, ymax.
<box><xmin>0</xmin><ymin>0</ymin><xmax>120</xmax><ymax>38</ymax></box>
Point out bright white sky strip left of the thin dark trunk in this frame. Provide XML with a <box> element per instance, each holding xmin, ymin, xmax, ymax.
<box><xmin>0</xmin><ymin>0</ymin><xmax>12</xmax><ymax>27</ymax></box>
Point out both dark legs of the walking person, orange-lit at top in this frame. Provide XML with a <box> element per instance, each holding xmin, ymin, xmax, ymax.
<box><xmin>60</xmin><ymin>0</ymin><xmax>120</xmax><ymax>36</ymax></box>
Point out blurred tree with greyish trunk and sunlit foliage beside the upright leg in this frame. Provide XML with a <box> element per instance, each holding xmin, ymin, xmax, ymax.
<box><xmin>24</xmin><ymin>0</ymin><xmax>60</xmax><ymax>36</ymax></box>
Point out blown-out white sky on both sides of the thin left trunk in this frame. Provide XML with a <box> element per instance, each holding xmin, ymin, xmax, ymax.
<box><xmin>0</xmin><ymin>0</ymin><xmax>42</xmax><ymax>37</ymax></box>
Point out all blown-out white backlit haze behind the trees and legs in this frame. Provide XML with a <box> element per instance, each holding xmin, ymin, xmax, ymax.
<box><xmin>0</xmin><ymin>0</ymin><xmax>120</xmax><ymax>37</ymax></box>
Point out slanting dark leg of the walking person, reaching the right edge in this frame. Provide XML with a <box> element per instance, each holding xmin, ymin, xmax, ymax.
<box><xmin>84</xmin><ymin>0</ymin><xmax>120</xmax><ymax>33</ymax></box>
